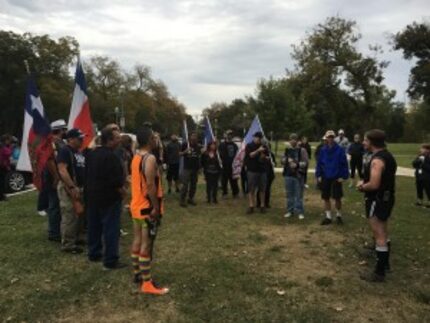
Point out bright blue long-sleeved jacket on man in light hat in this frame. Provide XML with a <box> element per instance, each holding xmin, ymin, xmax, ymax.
<box><xmin>315</xmin><ymin>143</ymin><xmax>349</xmax><ymax>179</ymax></box>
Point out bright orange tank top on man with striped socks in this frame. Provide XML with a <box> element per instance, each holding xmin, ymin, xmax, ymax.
<box><xmin>130</xmin><ymin>153</ymin><xmax>164</xmax><ymax>219</ymax></box>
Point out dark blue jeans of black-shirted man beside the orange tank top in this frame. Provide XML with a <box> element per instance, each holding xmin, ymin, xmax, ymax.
<box><xmin>87</xmin><ymin>201</ymin><xmax>122</xmax><ymax>267</ymax></box>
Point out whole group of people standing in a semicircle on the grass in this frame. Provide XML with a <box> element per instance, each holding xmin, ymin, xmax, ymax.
<box><xmin>2</xmin><ymin>120</ymin><xmax>430</xmax><ymax>295</ymax></box>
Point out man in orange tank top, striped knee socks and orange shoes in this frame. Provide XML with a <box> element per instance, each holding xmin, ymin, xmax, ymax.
<box><xmin>130</xmin><ymin>127</ymin><xmax>169</xmax><ymax>295</ymax></box>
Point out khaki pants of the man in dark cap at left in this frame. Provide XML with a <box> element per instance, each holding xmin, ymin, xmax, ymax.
<box><xmin>58</xmin><ymin>183</ymin><xmax>83</xmax><ymax>250</ymax></box>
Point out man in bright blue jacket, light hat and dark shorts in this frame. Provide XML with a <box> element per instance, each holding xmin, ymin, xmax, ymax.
<box><xmin>316</xmin><ymin>130</ymin><xmax>349</xmax><ymax>225</ymax></box>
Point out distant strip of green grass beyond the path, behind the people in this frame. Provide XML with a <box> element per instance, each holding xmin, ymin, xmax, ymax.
<box><xmin>272</xmin><ymin>141</ymin><xmax>421</xmax><ymax>168</ymax></box>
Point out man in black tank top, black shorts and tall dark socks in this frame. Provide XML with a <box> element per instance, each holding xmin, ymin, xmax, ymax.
<box><xmin>357</xmin><ymin>129</ymin><xmax>397</xmax><ymax>282</ymax></box>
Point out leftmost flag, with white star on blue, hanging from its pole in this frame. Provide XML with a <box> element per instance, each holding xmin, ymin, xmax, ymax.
<box><xmin>17</xmin><ymin>76</ymin><xmax>53</xmax><ymax>191</ymax></box>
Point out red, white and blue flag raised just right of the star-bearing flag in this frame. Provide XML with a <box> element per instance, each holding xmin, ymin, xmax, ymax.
<box><xmin>67</xmin><ymin>59</ymin><xmax>94</xmax><ymax>148</ymax></box>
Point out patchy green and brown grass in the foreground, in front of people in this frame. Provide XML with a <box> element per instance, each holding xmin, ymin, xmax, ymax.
<box><xmin>0</xmin><ymin>176</ymin><xmax>430</xmax><ymax>322</ymax></box>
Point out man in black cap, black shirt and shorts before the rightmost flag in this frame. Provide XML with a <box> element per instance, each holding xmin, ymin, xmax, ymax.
<box><xmin>245</xmin><ymin>131</ymin><xmax>270</xmax><ymax>214</ymax></box>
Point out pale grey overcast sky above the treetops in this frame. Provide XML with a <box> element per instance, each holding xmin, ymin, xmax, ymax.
<box><xmin>0</xmin><ymin>0</ymin><xmax>430</xmax><ymax>113</ymax></box>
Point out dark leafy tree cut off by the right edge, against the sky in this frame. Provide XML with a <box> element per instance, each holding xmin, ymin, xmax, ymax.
<box><xmin>393</xmin><ymin>22</ymin><xmax>430</xmax><ymax>102</ymax></box>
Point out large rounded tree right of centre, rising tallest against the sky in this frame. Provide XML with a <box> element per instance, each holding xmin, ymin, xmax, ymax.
<box><xmin>287</xmin><ymin>17</ymin><xmax>394</xmax><ymax>137</ymax></box>
